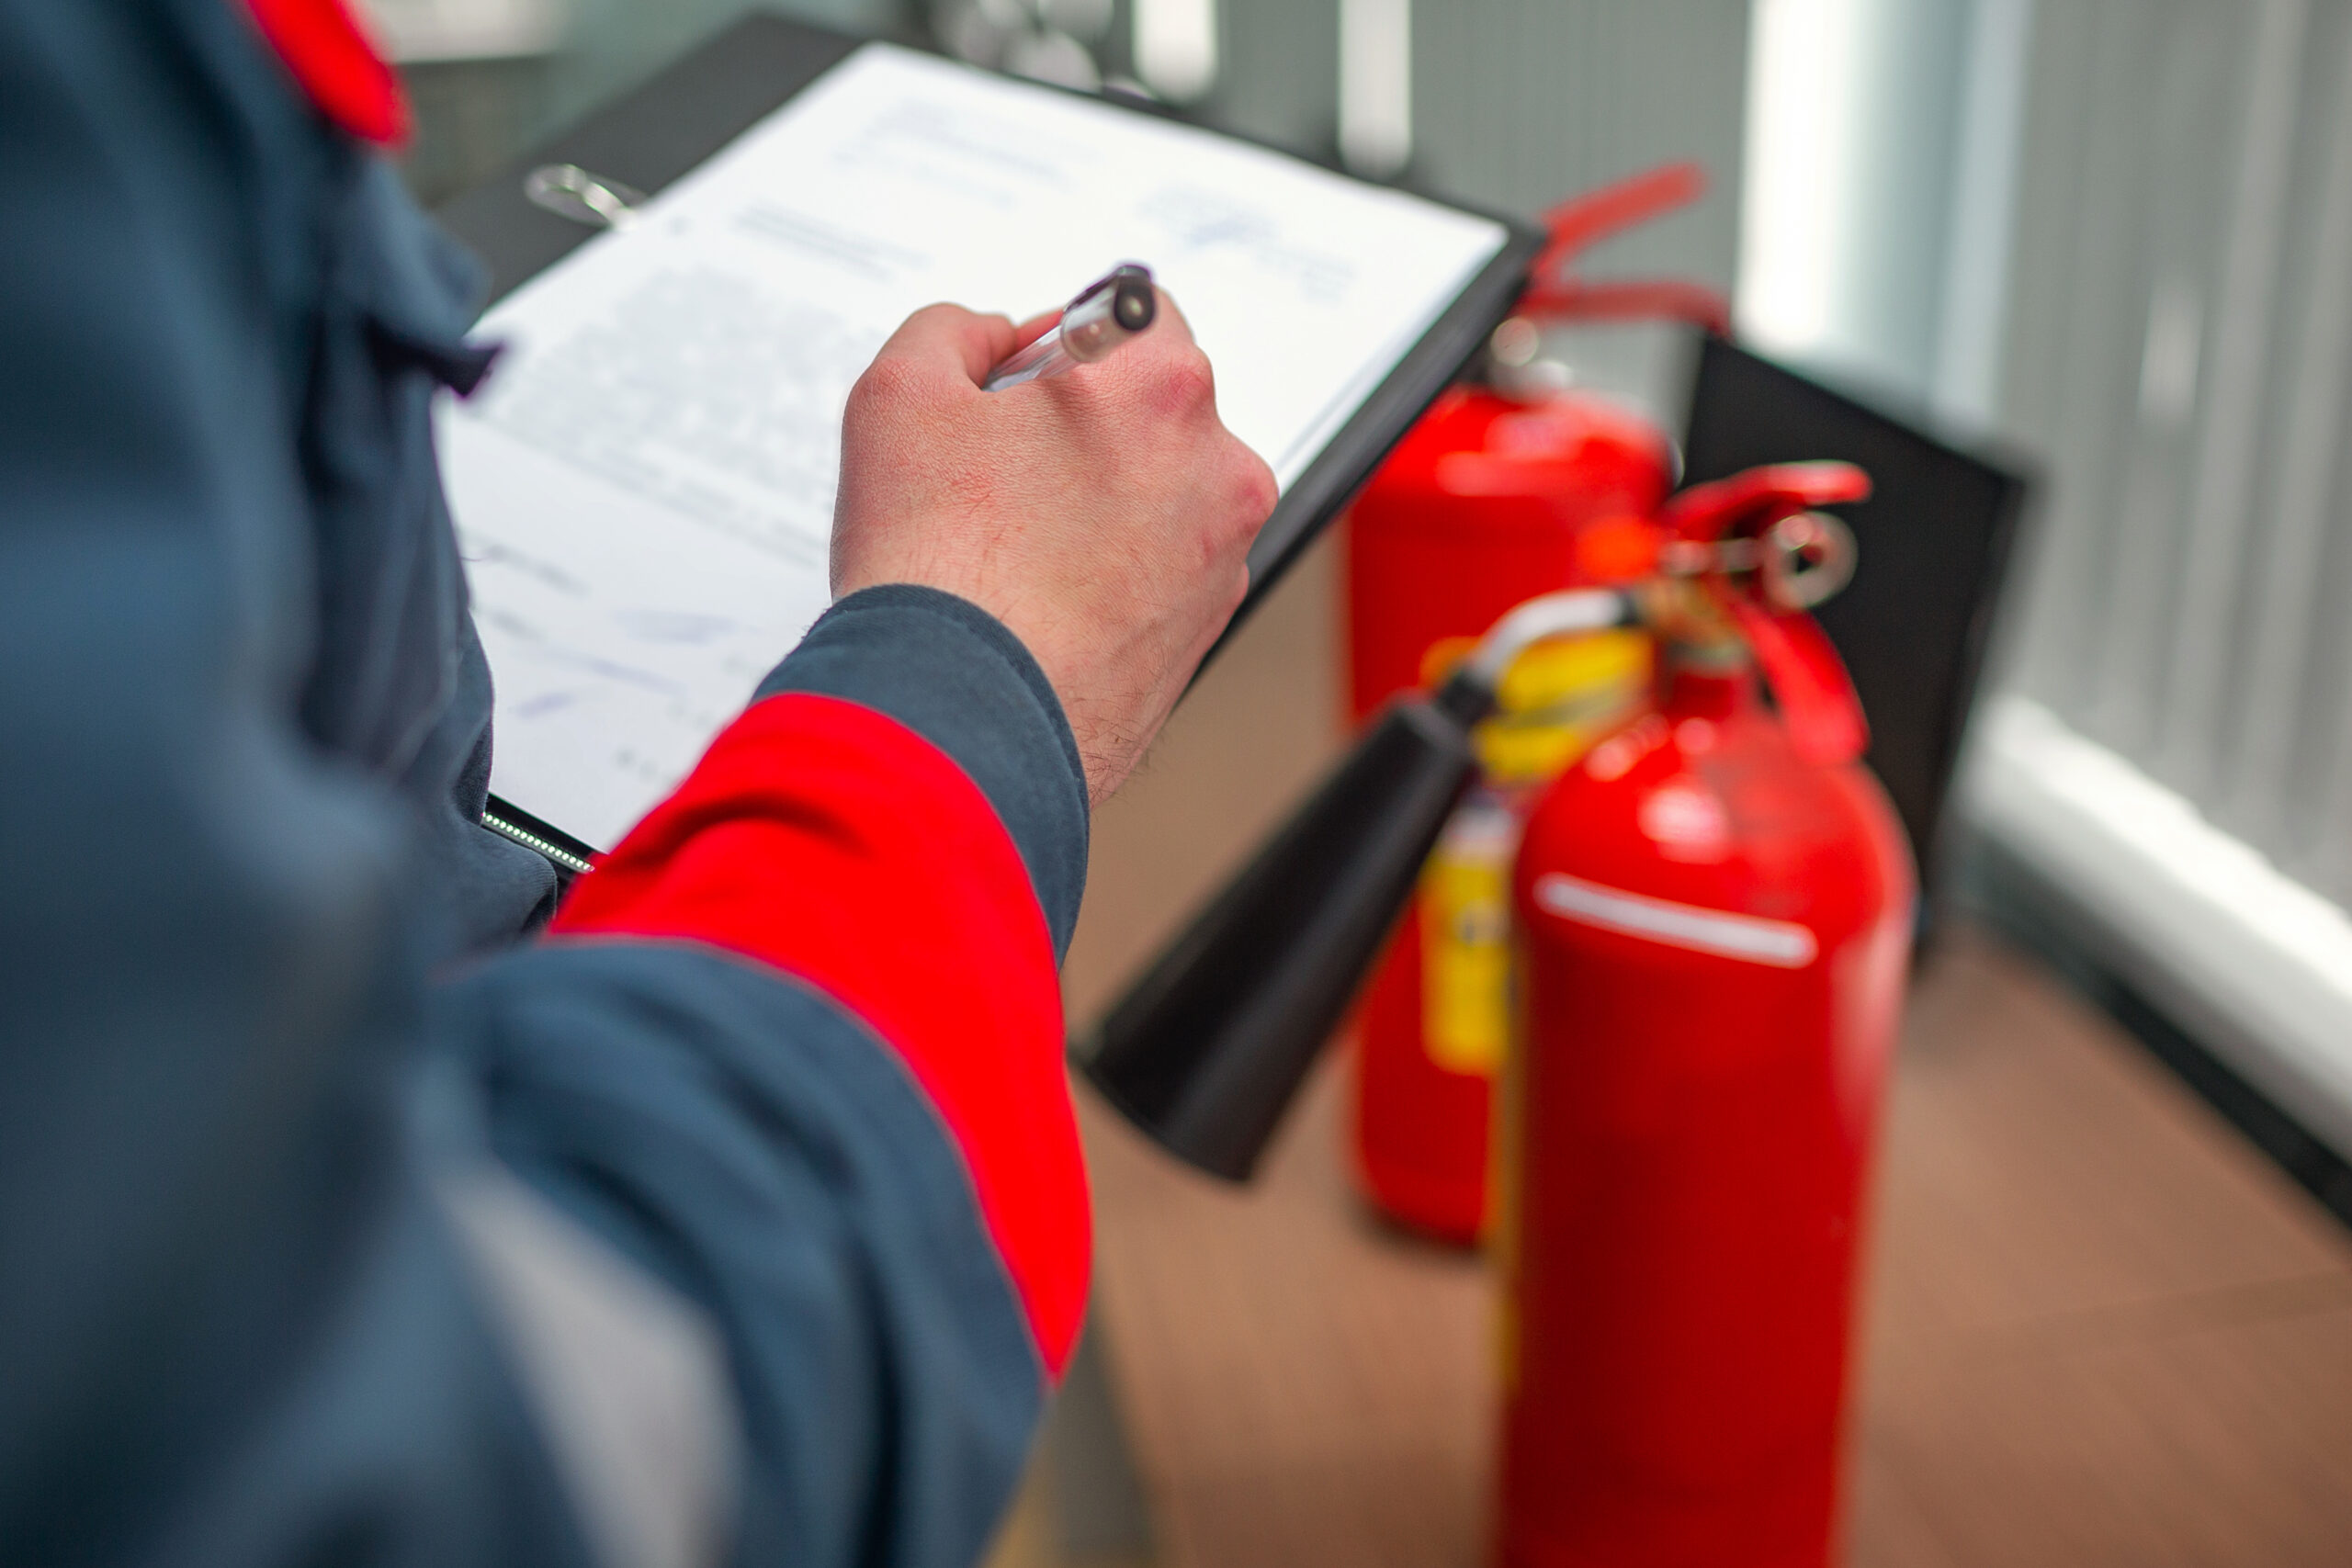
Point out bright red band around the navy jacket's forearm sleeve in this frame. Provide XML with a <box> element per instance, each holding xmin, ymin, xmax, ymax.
<box><xmin>550</xmin><ymin>694</ymin><xmax>1093</xmax><ymax>1378</ymax></box>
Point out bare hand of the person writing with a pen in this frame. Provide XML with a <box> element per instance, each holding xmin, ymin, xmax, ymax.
<box><xmin>832</xmin><ymin>294</ymin><xmax>1275</xmax><ymax>804</ymax></box>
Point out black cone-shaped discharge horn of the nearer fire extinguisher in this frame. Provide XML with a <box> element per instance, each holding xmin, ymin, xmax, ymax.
<box><xmin>1072</xmin><ymin>691</ymin><xmax>1491</xmax><ymax>1180</ymax></box>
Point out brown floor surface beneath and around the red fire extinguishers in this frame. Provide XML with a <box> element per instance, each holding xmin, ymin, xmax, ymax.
<box><xmin>1000</xmin><ymin>531</ymin><xmax>2352</xmax><ymax>1568</ymax></box>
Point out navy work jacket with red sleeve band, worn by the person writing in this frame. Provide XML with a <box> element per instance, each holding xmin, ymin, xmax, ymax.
<box><xmin>0</xmin><ymin>0</ymin><xmax>1087</xmax><ymax>1568</ymax></box>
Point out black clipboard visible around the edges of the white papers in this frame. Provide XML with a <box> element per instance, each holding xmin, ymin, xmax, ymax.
<box><xmin>435</xmin><ymin>14</ymin><xmax>1543</xmax><ymax>872</ymax></box>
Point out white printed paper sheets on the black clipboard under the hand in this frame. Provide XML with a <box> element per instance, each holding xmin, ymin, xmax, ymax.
<box><xmin>437</xmin><ymin>45</ymin><xmax>1508</xmax><ymax>849</ymax></box>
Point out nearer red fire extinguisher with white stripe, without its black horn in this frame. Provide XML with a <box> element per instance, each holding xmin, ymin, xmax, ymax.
<box><xmin>1496</xmin><ymin>463</ymin><xmax>1915</xmax><ymax>1568</ymax></box>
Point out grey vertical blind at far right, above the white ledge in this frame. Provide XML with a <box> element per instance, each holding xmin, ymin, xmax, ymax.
<box><xmin>2002</xmin><ymin>0</ymin><xmax>2352</xmax><ymax>903</ymax></box>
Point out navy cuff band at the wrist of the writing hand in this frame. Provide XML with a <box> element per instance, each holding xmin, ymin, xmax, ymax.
<box><xmin>757</xmin><ymin>583</ymin><xmax>1089</xmax><ymax>962</ymax></box>
